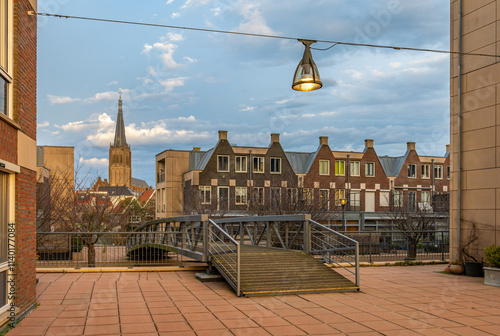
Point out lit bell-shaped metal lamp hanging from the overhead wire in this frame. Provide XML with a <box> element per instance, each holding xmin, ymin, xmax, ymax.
<box><xmin>292</xmin><ymin>40</ymin><xmax>323</xmax><ymax>91</ymax></box>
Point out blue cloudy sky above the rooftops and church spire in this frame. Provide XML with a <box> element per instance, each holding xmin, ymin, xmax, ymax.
<box><xmin>38</xmin><ymin>0</ymin><xmax>449</xmax><ymax>185</ymax></box>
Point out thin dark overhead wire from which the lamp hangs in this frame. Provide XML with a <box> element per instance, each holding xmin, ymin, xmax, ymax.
<box><xmin>34</xmin><ymin>12</ymin><xmax>500</xmax><ymax>57</ymax></box>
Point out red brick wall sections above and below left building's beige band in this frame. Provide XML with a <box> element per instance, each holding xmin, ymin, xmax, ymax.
<box><xmin>13</xmin><ymin>0</ymin><xmax>37</xmax><ymax>312</ymax></box>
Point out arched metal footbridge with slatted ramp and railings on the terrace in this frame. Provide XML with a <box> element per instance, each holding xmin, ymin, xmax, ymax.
<box><xmin>127</xmin><ymin>215</ymin><xmax>359</xmax><ymax>296</ymax></box>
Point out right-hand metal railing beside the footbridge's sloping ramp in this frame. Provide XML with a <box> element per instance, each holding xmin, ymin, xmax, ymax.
<box><xmin>306</xmin><ymin>220</ymin><xmax>359</xmax><ymax>286</ymax></box>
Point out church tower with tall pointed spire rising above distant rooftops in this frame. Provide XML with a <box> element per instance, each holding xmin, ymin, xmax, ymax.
<box><xmin>109</xmin><ymin>90</ymin><xmax>132</xmax><ymax>187</ymax></box>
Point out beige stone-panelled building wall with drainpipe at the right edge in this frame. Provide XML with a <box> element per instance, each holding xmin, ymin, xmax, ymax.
<box><xmin>450</xmin><ymin>0</ymin><xmax>500</xmax><ymax>258</ymax></box>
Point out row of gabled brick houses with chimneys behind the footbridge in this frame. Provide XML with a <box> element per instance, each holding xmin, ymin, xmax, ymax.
<box><xmin>156</xmin><ymin>131</ymin><xmax>450</xmax><ymax>230</ymax></box>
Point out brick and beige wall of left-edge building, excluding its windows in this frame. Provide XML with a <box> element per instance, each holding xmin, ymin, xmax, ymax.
<box><xmin>0</xmin><ymin>0</ymin><xmax>37</xmax><ymax>326</ymax></box>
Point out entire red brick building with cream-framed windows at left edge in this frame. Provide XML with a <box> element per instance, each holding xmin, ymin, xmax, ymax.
<box><xmin>0</xmin><ymin>0</ymin><xmax>37</xmax><ymax>326</ymax></box>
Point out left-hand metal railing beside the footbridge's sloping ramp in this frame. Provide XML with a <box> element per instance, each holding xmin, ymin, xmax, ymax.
<box><xmin>207</xmin><ymin>219</ymin><xmax>241</xmax><ymax>296</ymax></box>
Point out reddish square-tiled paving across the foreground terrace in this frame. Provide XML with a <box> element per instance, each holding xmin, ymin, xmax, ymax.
<box><xmin>7</xmin><ymin>265</ymin><xmax>500</xmax><ymax>336</ymax></box>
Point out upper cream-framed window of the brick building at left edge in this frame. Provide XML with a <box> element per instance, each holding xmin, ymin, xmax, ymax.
<box><xmin>0</xmin><ymin>0</ymin><xmax>12</xmax><ymax>118</ymax></box>
